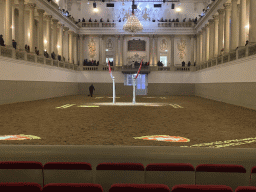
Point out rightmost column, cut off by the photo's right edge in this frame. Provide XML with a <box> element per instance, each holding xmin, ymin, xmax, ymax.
<box><xmin>249</xmin><ymin>0</ymin><xmax>256</xmax><ymax>43</ymax></box>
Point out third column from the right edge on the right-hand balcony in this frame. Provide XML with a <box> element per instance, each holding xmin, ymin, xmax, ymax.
<box><xmin>224</xmin><ymin>3</ymin><xmax>231</xmax><ymax>53</ymax></box>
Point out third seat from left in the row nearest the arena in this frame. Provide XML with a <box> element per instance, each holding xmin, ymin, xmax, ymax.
<box><xmin>96</xmin><ymin>163</ymin><xmax>145</xmax><ymax>192</ymax></box>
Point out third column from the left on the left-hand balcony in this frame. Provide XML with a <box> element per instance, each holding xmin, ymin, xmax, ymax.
<box><xmin>28</xmin><ymin>3</ymin><xmax>36</xmax><ymax>53</ymax></box>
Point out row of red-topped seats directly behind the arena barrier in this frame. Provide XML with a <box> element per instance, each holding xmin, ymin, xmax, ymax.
<box><xmin>0</xmin><ymin>161</ymin><xmax>256</xmax><ymax>191</ymax></box>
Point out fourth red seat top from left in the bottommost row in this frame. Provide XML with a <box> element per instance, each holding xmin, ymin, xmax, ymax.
<box><xmin>172</xmin><ymin>184</ymin><xmax>233</xmax><ymax>192</ymax></box>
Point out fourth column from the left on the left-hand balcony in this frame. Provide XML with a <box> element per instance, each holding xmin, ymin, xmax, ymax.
<box><xmin>37</xmin><ymin>9</ymin><xmax>45</xmax><ymax>55</ymax></box>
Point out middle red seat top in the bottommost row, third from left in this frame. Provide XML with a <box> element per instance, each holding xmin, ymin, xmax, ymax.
<box><xmin>109</xmin><ymin>183</ymin><xmax>170</xmax><ymax>192</ymax></box>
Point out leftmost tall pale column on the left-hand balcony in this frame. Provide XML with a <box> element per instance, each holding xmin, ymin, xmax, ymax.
<box><xmin>4</xmin><ymin>0</ymin><xmax>13</xmax><ymax>46</ymax></box>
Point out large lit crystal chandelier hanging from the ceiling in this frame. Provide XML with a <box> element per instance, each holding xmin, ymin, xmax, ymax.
<box><xmin>123</xmin><ymin>0</ymin><xmax>143</xmax><ymax>33</ymax></box>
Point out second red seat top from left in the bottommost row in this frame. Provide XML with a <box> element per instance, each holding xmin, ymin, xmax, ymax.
<box><xmin>43</xmin><ymin>183</ymin><xmax>103</xmax><ymax>192</ymax></box>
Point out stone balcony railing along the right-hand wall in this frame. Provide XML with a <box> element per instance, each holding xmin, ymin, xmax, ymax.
<box><xmin>196</xmin><ymin>44</ymin><xmax>256</xmax><ymax>71</ymax></box>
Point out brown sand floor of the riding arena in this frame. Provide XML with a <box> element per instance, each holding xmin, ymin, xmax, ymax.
<box><xmin>0</xmin><ymin>95</ymin><xmax>256</xmax><ymax>148</ymax></box>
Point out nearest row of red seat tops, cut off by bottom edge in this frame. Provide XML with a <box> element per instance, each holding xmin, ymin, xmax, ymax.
<box><xmin>0</xmin><ymin>182</ymin><xmax>256</xmax><ymax>192</ymax></box>
